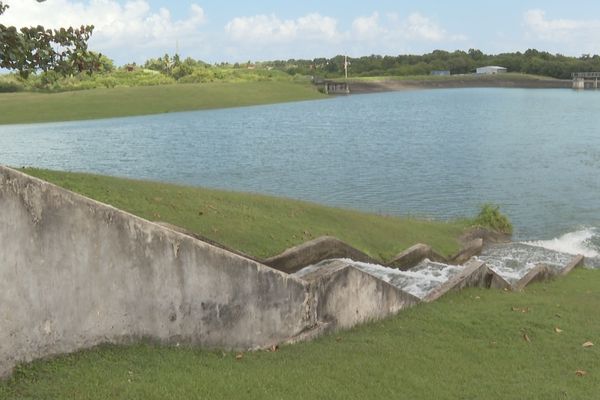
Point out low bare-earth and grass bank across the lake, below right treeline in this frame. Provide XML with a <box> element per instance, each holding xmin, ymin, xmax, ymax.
<box><xmin>348</xmin><ymin>74</ymin><xmax>572</xmax><ymax>94</ymax></box>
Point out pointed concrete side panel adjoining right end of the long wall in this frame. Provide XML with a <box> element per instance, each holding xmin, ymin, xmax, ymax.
<box><xmin>303</xmin><ymin>261</ymin><xmax>420</xmax><ymax>329</ymax></box>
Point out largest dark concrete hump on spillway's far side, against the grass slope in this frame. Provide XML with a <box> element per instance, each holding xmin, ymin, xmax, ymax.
<box><xmin>264</xmin><ymin>236</ymin><xmax>379</xmax><ymax>274</ymax></box>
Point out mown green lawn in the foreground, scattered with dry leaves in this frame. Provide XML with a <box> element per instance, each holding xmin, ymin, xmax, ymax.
<box><xmin>0</xmin><ymin>270</ymin><xmax>600</xmax><ymax>400</ymax></box>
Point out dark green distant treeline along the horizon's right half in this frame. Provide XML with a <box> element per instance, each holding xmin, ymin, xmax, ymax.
<box><xmin>265</xmin><ymin>49</ymin><xmax>600</xmax><ymax>79</ymax></box>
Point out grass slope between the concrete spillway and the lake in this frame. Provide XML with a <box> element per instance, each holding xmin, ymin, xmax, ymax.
<box><xmin>19</xmin><ymin>169</ymin><xmax>469</xmax><ymax>260</ymax></box>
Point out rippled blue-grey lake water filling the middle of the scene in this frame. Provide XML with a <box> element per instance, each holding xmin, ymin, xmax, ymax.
<box><xmin>0</xmin><ymin>89</ymin><xmax>600</xmax><ymax>255</ymax></box>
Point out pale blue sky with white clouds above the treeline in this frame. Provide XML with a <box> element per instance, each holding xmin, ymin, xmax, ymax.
<box><xmin>0</xmin><ymin>0</ymin><xmax>600</xmax><ymax>65</ymax></box>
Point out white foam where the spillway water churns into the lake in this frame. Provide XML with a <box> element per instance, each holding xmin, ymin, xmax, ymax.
<box><xmin>523</xmin><ymin>228</ymin><xmax>600</xmax><ymax>258</ymax></box>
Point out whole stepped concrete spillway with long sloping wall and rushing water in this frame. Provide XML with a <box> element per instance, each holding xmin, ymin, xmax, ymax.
<box><xmin>0</xmin><ymin>166</ymin><xmax>582</xmax><ymax>377</ymax></box>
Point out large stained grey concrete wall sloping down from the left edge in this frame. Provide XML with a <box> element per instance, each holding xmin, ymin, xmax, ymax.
<box><xmin>0</xmin><ymin>167</ymin><xmax>317</xmax><ymax>375</ymax></box>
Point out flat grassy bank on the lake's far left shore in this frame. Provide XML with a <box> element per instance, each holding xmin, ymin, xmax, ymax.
<box><xmin>0</xmin><ymin>81</ymin><xmax>325</xmax><ymax>124</ymax></box>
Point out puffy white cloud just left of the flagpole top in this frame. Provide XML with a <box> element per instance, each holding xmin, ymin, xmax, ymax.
<box><xmin>225</xmin><ymin>13</ymin><xmax>341</xmax><ymax>46</ymax></box>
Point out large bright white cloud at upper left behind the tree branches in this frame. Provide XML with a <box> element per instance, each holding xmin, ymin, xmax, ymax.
<box><xmin>0</xmin><ymin>0</ymin><xmax>206</xmax><ymax>59</ymax></box>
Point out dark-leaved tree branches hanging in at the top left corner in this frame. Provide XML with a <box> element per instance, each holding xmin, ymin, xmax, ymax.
<box><xmin>0</xmin><ymin>0</ymin><xmax>101</xmax><ymax>78</ymax></box>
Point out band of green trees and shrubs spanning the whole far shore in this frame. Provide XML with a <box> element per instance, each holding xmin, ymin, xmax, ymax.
<box><xmin>0</xmin><ymin>49</ymin><xmax>600</xmax><ymax>92</ymax></box>
